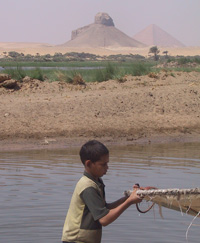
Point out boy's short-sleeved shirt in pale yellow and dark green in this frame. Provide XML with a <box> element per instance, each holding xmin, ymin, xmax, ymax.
<box><xmin>62</xmin><ymin>172</ymin><xmax>109</xmax><ymax>243</ymax></box>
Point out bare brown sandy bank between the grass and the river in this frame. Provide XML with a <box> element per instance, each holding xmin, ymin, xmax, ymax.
<box><xmin>0</xmin><ymin>69</ymin><xmax>200</xmax><ymax>151</ymax></box>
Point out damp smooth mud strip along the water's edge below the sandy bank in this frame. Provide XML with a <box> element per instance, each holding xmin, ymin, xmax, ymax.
<box><xmin>0</xmin><ymin>133</ymin><xmax>200</xmax><ymax>152</ymax></box>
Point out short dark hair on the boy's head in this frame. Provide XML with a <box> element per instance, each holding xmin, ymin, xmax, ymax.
<box><xmin>79</xmin><ymin>140</ymin><xmax>109</xmax><ymax>164</ymax></box>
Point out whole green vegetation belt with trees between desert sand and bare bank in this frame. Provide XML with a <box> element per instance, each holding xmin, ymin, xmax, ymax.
<box><xmin>0</xmin><ymin>50</ymin><xmax>200</xmax><ymax>84</ymax></box>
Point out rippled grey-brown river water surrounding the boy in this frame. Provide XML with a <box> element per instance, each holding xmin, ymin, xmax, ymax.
<box><xmin>0</xmin><ymin>144</ymin><xmax>200</xmax><ymax>243</ymax></box>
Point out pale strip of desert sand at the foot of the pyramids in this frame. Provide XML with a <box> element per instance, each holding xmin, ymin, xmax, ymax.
<box><xmin>0</xmin><ymin>42</ymin><xmax>200</xmax><ymax>57</ymax></box>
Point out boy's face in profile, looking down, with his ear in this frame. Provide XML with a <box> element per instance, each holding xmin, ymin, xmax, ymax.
<box><xmin>85</xmin><ymin>154</ymin><xmax>109</xmax><ymax>179</ymax></box>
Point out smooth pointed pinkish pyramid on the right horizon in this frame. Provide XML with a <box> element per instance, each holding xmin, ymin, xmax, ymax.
<box><xmin>133</xmin><ymin>24</ymin><xmax>184</xmax><ymax>47</ymax></box>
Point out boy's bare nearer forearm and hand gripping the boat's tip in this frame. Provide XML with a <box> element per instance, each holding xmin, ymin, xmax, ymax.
<box><xmin>99</xmin><ymin>190</ymin><xmax>142</xmax><ymax>226</ymax></box>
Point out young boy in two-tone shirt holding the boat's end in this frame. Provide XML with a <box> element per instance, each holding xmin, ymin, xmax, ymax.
<box><xmin>62</xmin><ymin>140</ymin><xmax>142</xmax><ymax>243</ymax></box>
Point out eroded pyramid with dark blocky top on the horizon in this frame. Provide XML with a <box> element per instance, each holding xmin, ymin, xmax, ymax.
<box><xmin>61</xmin><ymin>13</ymin><xmax>145</xmax><ymax>48</ymax></box>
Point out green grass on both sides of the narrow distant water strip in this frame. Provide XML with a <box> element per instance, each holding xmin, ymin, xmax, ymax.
<box><xmin>0</xmin><ymin>60</ymin><xmax>200</xmax><ymax>83</ymax></box>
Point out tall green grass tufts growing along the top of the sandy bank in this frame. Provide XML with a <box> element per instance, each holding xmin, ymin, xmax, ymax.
<box><xmin>0</xmin><ymin>62</ymin><xmax>153</xmax><ymax>83</ymax></box>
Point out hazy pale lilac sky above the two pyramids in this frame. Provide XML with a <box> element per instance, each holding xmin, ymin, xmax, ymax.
<box><xmin>0</xmin><ymin>0</ymin><xmax>200</xmax><ymax>46</ymax></box>
